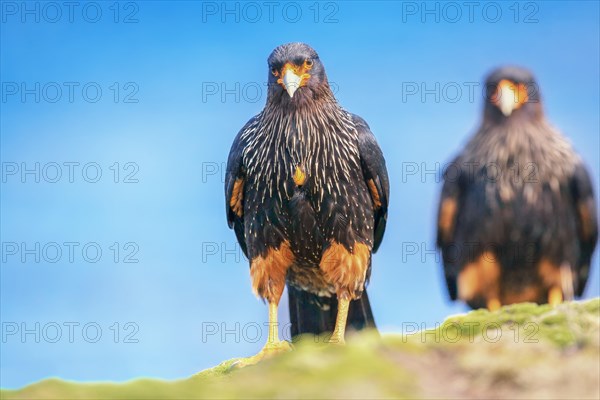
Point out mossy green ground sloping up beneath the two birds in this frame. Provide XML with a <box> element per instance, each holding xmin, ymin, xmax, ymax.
<box><xmin>0</xmin><ymin>299</ymin><xmax>600</xmax><ymax>399</ymax></box>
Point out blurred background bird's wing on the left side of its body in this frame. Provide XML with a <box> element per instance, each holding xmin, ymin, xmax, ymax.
<box><xmin>437</xmin><ymin>161</ymin><xmax>461</xmax><ymax>300</ymax></box>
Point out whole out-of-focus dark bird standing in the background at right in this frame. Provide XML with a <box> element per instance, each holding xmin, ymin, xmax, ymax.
<box><xmin>437</xmin><ymin>67</ymin><xmax>598</xmax><ymax>310</ymax></box>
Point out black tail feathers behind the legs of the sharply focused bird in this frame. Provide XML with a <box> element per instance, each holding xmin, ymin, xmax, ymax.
<box><xmin>288</xmin><ymin>286</ymin><xmax>376</xmax><ymax>337</ymax></box>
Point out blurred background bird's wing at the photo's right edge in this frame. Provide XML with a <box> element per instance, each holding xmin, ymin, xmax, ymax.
<box><xmin>571</xmin><ymin>163</ymin><xmax>598</xmax><ymax>296</ymax></box>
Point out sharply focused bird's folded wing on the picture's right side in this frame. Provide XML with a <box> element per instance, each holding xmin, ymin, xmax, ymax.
<box><xmin>352</xmin><ymin>115</ymin><xmax>390</xmax><ymax>253</ymax></box>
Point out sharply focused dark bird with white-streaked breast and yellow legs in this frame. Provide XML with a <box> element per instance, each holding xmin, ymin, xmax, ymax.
<box><xmin>225</xmin><ymin>43</ymin><xmax>389</xmax><ymax>363</ymax></box>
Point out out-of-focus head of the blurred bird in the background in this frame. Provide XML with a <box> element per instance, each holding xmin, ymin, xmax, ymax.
<box><xmin>485</xmin><ymin>67</ymin><xmax>541</xmax><ymax>119</ymax></box>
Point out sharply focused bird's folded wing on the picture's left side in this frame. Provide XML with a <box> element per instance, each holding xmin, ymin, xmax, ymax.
<box><xmin>225</xmin><ymin>117</ymin><xmax>257</xmax><ymax>257</ymax></box>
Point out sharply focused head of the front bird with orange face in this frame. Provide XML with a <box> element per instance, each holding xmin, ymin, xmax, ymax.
<box><xmin>268</xmin><ymin>43</ymin><xmax>331</xmax><ymax>103</ymax></box>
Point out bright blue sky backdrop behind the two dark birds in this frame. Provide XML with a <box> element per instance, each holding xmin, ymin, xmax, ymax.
<box><xmin>0</xmin><ymin>1</ymin><xmax>600</xmax><ymax>388</ymax></box>
